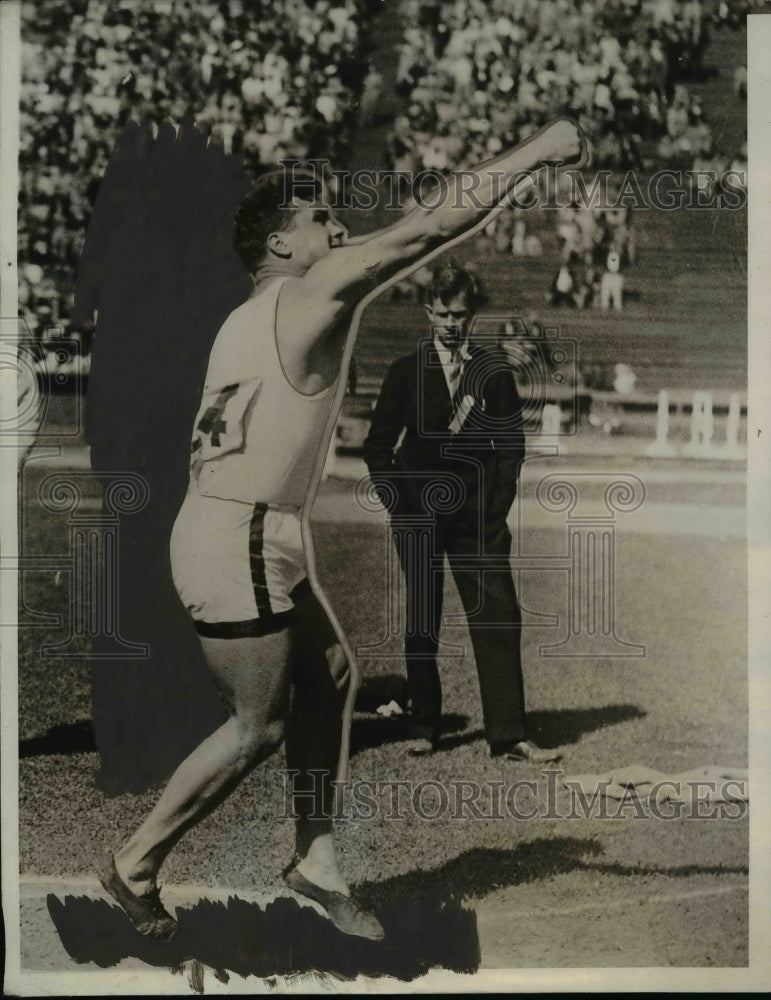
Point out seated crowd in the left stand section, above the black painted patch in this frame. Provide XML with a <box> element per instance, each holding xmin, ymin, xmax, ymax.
<box><xmin>19</xmin><ymin>0</ymin><xmax>379</xmax><ymax>337</ymax></box>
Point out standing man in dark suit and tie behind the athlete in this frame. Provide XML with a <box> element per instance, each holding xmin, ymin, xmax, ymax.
<box><xmin>364</xmin><ymin>264</ymin><xmax>560</xmax><ymax>763</ymax></box>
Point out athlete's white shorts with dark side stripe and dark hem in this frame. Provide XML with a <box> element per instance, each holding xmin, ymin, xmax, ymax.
<box><xmin>170</xmin><ymin>493</ymin><xmax>310</xmax><ymax>638</ymax></box>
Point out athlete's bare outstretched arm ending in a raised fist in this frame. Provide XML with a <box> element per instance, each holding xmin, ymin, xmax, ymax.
<box><xmin>297</xmin><ymin>118</ymin><xmax>587</xmax><ymax>308</ymax></box>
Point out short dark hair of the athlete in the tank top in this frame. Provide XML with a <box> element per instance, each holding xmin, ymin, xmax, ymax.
<box><xmin>233</xmin><ymin>168</ymin><xmax>324</xmax><ymax>274</ymax></box>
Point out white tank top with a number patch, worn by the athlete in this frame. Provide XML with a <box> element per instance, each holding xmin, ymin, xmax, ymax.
<box><xmin>189</xmin><ymin>278</ymin><xmax>337</xmax><ymax>507</ymax></box>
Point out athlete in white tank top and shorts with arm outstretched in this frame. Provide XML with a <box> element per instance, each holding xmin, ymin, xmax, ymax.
<box><xmin>100</xmin><ymin>118</ymin><xmax>586</xmax><ymax>940</ymax></box>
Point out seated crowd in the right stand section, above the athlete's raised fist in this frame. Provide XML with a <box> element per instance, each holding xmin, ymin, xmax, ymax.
<box><xmin>391</xmin><ymin>0</ymin><xmax>762</xmax><ymax>170</ymax></box>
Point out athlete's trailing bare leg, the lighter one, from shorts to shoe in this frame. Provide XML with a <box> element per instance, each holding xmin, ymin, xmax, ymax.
<box><xmin>115</xmin><ymin>629</ymin><xmax>292</xmax><ymax>895</ymax></box>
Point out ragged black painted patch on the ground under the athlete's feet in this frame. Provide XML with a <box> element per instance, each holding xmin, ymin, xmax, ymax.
<box><xmin>47</xmin><ymin>894</ymin><xmax>480</xmax><ymax>981</ymax></box>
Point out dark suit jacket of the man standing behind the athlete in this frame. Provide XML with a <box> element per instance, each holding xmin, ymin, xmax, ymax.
<box><xmin>364</xmin><ymin>339</ymin><xmax>525</xmax><ymax>537</ymax></box>
